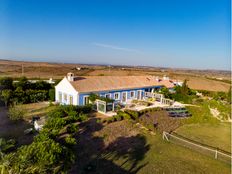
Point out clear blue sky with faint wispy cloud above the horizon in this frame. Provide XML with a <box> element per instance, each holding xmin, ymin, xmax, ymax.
<box><xmin>0</xmin><ymin>0</ymin><xmax>231</xmax><ymax>70</ymax></box>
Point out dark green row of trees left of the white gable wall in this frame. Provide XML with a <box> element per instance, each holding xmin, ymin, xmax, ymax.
<box><xmin>0</xmin><ymin>77</ymin><xmax>55</xmax><ymax>106</ymax></box>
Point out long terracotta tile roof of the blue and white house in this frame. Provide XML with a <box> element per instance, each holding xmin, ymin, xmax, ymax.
<box><xmin>70</xmin><ymin>76</ymin><xmax>174</xmax><ymax>92</ymax></box>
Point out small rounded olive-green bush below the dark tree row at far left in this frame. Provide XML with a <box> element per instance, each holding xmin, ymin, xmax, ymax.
<box><xmin>8</xmin><ymin>106</ymin><xmax>26</xmax><ymax>121</ymax></box>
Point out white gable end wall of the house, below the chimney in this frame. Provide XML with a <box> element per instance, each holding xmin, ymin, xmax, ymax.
<box><xmin>55</xmin><ymin>77</ymin><xmax>79</xmax><ymax>105</ymax></box>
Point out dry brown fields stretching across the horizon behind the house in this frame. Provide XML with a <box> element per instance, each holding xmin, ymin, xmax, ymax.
<box><xmin>0</xmin><ymin>60</ymin><xmax>230</xmax><ymax>92</ymax></box>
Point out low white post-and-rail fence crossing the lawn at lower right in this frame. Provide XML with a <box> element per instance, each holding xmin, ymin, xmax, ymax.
<box><xmin>163</xmin><ymin>131</ymin><xmax>232</xmax><ymax>163</ymax></box>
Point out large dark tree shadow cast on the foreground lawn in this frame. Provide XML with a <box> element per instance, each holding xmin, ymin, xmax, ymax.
<box><xmin>69</xmin><ymin>114</ymin><xmax>150</xmax><ymax>174</ymax></box>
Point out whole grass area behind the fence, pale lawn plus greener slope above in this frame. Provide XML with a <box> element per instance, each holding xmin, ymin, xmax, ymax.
<box><xmin>176</xmin><ymin>100</ymin><xmax>231</xmax><ymax>152</ymax></box>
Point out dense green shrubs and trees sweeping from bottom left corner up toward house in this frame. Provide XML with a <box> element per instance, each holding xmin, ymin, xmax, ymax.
<box><xmin>0</xmin><ymin>106</ymin><xmax>91</xmax><ymax>173</ymax></box>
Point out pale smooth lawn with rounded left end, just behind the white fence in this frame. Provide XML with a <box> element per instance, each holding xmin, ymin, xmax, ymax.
<box><xmin>175</xmin><ymin>123</ymin><xmax>231</xmax><ymax>152</ymax></box>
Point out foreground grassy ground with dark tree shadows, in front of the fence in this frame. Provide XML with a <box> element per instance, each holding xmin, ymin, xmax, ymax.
<box><xmin>70</xmin><ymin>119</ymin><xmax>230</xmax><ymax>174</ymax></box>
